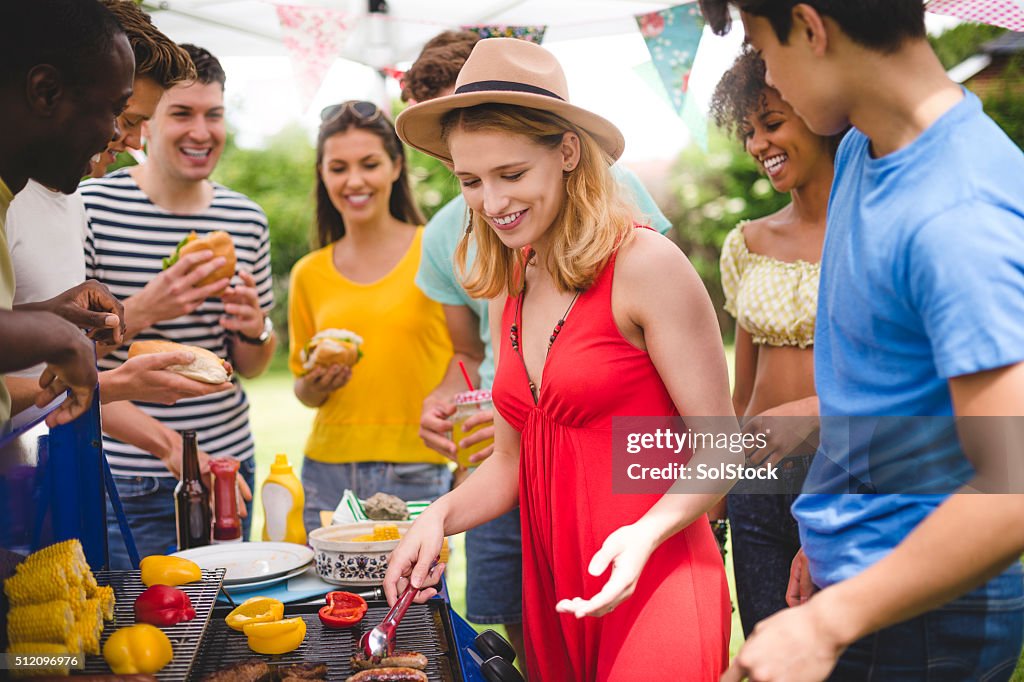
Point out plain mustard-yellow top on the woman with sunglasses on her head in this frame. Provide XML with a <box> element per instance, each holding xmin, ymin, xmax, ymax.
<box><xmin>288</xmin><ymin>227</ymin><xmax>452</xmax><ymax>464</ymax></box>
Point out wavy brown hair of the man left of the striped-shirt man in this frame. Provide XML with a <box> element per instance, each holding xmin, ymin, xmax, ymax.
<box><xmin>100</xmin><ymin>0</ymin><xmax>196</xmax><ymax>90</ymax></box>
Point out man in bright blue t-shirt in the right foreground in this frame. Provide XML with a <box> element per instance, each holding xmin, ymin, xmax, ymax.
<box><xmin>701</xmin><ymin>0</ymin><xmax>1024</xmax><ymax>680</ymax></box>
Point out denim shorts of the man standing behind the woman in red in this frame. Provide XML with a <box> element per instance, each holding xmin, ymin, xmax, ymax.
<box><xmin>466</xmin><ymin>507</ymin><xmax>522</xmax><ymax>625</ymax></box>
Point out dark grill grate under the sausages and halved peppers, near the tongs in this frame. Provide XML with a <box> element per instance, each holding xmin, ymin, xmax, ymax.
<box><xmin>191</xmin><ymin>599</ymin><xmax>461</xmax><ymax>682</ymax></box>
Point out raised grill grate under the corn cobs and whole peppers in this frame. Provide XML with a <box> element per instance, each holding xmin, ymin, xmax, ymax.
<box><xmin>75</xmin><ymin>568</ymin><xmax>226</xmax><ymax>682</ymax></box>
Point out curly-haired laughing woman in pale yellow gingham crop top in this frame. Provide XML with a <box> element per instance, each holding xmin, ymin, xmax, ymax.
<box><xmin>712</xmin><ymin>48</ymin><xmax>840</xmax><ymax>636</ymax></box>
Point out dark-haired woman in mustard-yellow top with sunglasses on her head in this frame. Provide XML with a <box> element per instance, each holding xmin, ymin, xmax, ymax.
<box><xmin>288</xmin><ymin>101</ymin><xmax>452</xmax><ymax>529</ymax></box>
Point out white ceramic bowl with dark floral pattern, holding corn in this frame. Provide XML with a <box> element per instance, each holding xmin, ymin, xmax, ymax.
<box><xmin>309</xmin><ymin>521</ymin><xmax>413</xmax><ymax>585</ymax></box>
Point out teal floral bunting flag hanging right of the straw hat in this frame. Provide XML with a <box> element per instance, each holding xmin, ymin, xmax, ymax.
<box><xmin>636</xmin><ymin>3</ymin><xmax>708</xmax><ymax>150</ymax></box>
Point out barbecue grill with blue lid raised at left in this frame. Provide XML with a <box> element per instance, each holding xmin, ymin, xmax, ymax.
<box><xmin>0</xmin><ymin>398</ymin><xmax>515</xmax><ymax>682</ymax></box>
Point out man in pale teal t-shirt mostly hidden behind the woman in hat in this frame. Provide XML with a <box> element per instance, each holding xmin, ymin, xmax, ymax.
<box><xmin>402</xmin><ymin>31</ymin><xmax>672</xmax><ymax>670</ymax></box>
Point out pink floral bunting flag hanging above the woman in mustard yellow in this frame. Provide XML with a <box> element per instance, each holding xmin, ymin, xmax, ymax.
<box><xmin>276</xmin><ymin>5</ymin><xmax>348</xmax><ymax>110</ymax></box>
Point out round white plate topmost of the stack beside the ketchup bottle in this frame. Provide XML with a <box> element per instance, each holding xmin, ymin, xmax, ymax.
<box><xmin>173</xmin><ymin>543</ymin><xmax>313</xmax><ymax>585</ymax></box>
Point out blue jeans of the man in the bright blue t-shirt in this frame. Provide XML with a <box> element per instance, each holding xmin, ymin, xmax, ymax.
<box><xmin>828</xmin><ymin>563</ymin><xmax>1024</xmax><ymax>682</ymax></box>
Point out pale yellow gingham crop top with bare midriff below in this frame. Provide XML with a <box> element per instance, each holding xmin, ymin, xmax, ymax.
<box><xmin>721</xmin><ymin>221</ymin><xmax>821</xmax><ymax>348</ymax></box>
